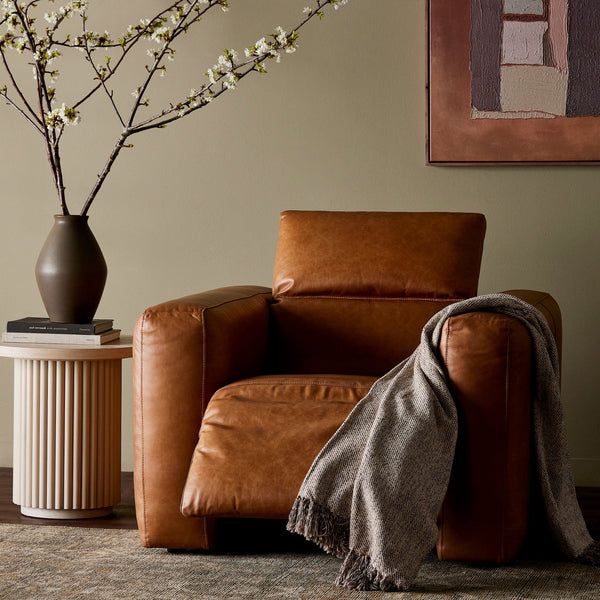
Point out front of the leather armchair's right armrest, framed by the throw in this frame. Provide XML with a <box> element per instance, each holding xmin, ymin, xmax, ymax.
<box><xmin>437</xmin><ymin>312</ymin><xmax>532</xmax><ymax>563</ymax></box>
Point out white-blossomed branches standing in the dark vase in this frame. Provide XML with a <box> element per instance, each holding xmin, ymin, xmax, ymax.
<box><xmin>0</xmin><ymin>0</ymin><xmax>347</xmax><ymax>215</ymax></box>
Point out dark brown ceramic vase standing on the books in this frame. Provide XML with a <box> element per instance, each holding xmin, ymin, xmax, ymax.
<box><xmin>35</xmin><ymin>215</ymin><xmax>108</xmax><ymax>323</ymax></box>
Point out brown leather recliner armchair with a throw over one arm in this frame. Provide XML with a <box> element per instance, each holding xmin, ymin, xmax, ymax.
<box><xmin>134</xmin><ymin>211</ymin><xmax>561</xmax><ymax>562</ymax></box>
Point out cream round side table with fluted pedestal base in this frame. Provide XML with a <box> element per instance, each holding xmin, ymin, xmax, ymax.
<box><xmin>0</xmin><ymin>337</ymin><xmax>132</xmax><ymax>519</ymax></box>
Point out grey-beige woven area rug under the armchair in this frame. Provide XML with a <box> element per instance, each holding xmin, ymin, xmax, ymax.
<box><xmin>0</xmin><ymin>525</ymin><xmax>600</xmax><ymax>600</ymax></box>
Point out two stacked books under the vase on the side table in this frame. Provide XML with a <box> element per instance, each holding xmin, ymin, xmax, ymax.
<box><xmin>2</xmin><ymin>317</ymin><xmax>121</xmax><ymax>346</ymax></box>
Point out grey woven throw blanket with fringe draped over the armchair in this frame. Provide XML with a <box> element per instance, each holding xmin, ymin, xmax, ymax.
<box><xmin>287</xmin><ymin>294</ymin><xmax>599</xmax><ymax>591</ymax></box>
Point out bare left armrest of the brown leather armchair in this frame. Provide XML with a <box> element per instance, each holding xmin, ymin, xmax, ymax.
<box><xmin>133</xmin><ymin>286</ymin><xmax>271</xmax><ymax>548</ymax></box>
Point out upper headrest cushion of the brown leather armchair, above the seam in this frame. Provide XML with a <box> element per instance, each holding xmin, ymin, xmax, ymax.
<box><xmin>273</xmin><ymin>211</ymin><xmax>485</xmax><ymax>300</ymax></box>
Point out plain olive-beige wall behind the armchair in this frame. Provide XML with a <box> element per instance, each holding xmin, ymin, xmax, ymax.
<box><xmin>0</xmin><ymin>0</ymin><xmax>600</xmax><ymax>485</ymax></box>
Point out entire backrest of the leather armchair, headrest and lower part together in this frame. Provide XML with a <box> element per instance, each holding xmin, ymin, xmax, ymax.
<box><xmin>271</xmin><ymin>211</ymin><xmax>485</xmax><ymax>375</ymax></box>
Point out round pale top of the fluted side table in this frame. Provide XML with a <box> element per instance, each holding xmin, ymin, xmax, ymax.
<box><xmin>0</xmin><ymin>336</ymin><xmax>133</xmax><ymax>360</ymax></box>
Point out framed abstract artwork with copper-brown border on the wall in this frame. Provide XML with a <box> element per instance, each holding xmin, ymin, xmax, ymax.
<box><xmin>427</xmin><ymin>0</ymin><xmax>600</xmax><ymax>164</ymax></box>
